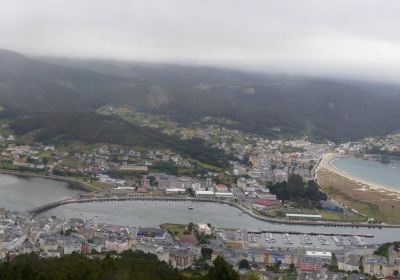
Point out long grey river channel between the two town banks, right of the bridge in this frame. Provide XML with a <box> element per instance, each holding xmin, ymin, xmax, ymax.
<box><xmin>44</xmin><ymin>201</ymin><xmax>400</xmax><ymax>243</ymax></box>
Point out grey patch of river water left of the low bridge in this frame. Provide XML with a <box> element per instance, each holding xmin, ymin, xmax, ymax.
<box><xmin>0</xmin><ymin>175</ymin><xmax>82</xmax><ymax>211</ymax></box>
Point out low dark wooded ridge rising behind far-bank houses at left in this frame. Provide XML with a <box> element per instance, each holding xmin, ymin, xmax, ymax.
<box><xmin>11</xmin><ymin>112</ymin><xmax>229</xmax><ymax>167</ymax></box>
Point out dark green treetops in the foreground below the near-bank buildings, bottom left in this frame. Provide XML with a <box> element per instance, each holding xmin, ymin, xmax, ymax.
<box><xmin>0</xmin><ymin>250</ymin><xmax>239</xmax><ymax>280</ymax></box>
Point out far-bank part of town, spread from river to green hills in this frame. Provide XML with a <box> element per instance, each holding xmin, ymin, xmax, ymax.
<box><xmin>0</xmin><ymin>115</ymin><xmax>400</xmax><ymax>219</ymax></box>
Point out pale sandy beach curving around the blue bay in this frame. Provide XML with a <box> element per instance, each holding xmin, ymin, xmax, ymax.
<box><xmin>316</xmin><ymin>153</ymin><xmax>400</xmax><ymax>199</ymax></box>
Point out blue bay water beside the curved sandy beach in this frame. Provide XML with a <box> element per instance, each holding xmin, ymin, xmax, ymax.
<box><xmin>332</xmin><ymin>158</ymin><xmax>400</xmax><ymax>190</ymax></box>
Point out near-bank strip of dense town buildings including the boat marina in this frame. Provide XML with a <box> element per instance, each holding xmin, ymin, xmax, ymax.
<box><xmin>0</xmin><ymin>209</ymin><xmax>400</xmax><ymax>279</ymax></box>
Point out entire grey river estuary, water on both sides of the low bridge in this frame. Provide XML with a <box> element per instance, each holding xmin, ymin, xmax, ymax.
<box><xmin>0</xmin><ymin>175</ymin><xmax>400</xmax><ymax>243</ymax></box>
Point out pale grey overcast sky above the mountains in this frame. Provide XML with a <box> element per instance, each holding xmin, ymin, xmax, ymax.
<box><xmin>0</xmin><ymin>0</ymin><xmax>400</xmax><ymax>81</ymax></box>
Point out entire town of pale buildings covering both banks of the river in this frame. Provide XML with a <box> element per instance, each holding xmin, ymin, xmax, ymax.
<box><xmin>0</xmin><ymin>115</ymin><xmax>400</xmax><ymax>279</ymax></box>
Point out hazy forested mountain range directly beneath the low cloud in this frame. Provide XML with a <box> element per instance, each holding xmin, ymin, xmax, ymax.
<box><xmin>0</xmin><ymin>50</ymin><xmax>400</xmax><ymax>141</ymax></box>
